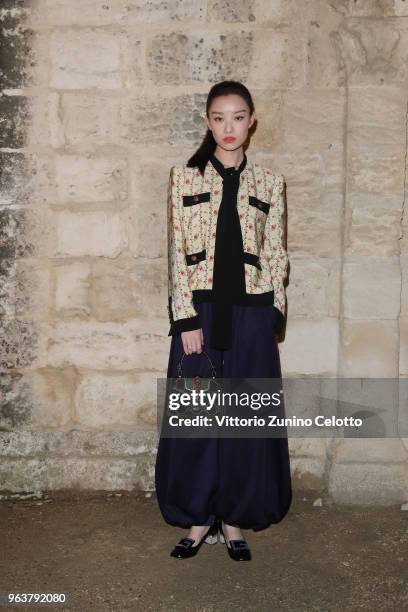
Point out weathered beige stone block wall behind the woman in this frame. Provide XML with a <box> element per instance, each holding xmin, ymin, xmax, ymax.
<box><xmin>0</xmin><ymin>0</ymin><xmax>408</xmax><ymax>504</ymax></box>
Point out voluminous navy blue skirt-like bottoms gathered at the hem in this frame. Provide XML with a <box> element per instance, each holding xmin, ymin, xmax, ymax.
<box><xmin>155</xmin><ymin>303</ymin><xmax>292</xmax><ymax>531</ymax></box>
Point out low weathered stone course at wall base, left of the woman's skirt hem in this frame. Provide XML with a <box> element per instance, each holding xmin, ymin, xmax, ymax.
<box><xmin>0</xmin><ymin>429</ymin><xmax>158</xmax><ymax>491</ymax></box>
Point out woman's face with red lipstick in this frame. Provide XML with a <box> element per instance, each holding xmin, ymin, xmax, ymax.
<box><xmin>206</xmin><ymin>94</ymin><xmax>255</xmax><ymax>151</ymax></box>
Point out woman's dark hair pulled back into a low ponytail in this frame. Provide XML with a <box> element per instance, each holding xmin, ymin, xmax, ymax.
<box><xmin>187</xmin><ymin>81</ymin><xmax>255</xmax><ymax>175</ymax></box>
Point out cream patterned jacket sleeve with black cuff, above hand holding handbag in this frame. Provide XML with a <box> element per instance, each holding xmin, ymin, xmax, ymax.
<box><xmin>167</xmin><ymin>166</ymin><xmax>201</xmax><ymax>336</ymax></box>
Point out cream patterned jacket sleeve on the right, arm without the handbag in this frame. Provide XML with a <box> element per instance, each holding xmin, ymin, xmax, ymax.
<box><xmin>263</xmin><ymin>174</ymin><xmax>289</xmax><ymax>333</ymax></box>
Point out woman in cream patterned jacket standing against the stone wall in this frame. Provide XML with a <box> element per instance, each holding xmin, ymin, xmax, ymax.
<box><xmin>155</xmin><ymin>81</ymin><xmax>292</xmax><ymax>561</ymax></box>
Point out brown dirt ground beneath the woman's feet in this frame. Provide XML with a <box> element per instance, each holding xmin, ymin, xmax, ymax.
<box><xmin>0</xmin><ymin>492</ymin><xmax>408</xmax><ymax>612</ymax></box>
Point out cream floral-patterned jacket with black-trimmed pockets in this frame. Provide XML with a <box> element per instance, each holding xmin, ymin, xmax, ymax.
<box><xmin>167</xmin><ymin>159</ymin><xmax>288</xmax><ymax>330</ymax></box>
